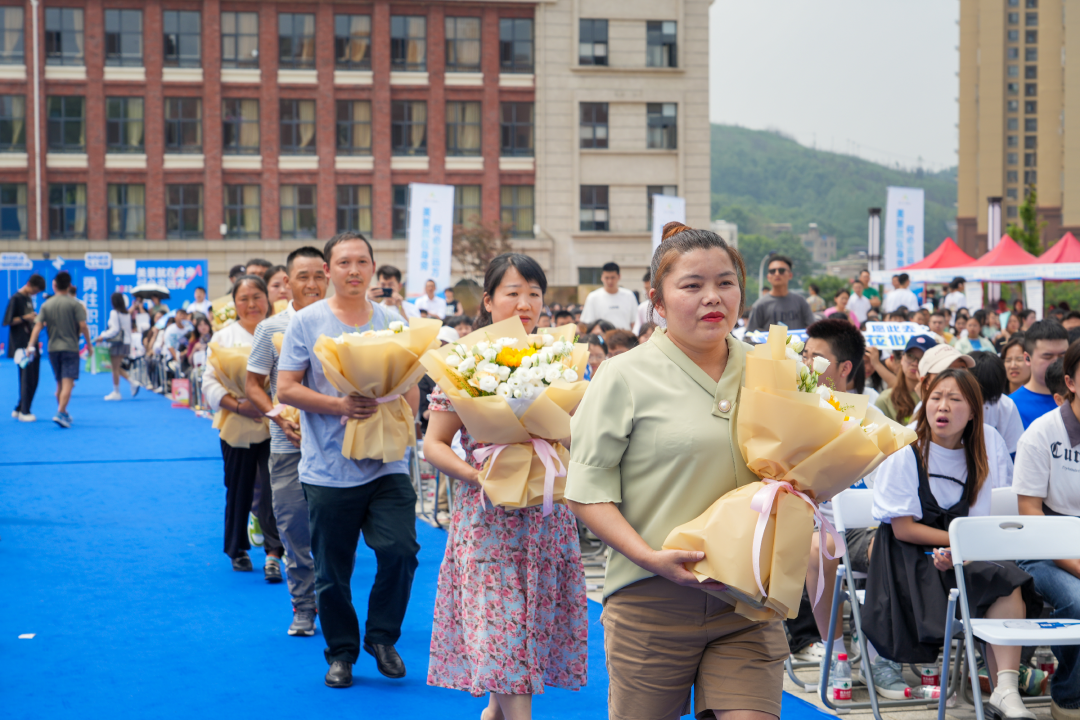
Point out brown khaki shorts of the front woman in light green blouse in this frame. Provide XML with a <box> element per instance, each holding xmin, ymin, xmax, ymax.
<box><xmin>600</xmin><ymin>578</ymin><xmax>788</xmax><ymax>720</ymax></box>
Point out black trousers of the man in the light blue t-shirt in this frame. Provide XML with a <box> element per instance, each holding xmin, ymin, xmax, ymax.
<box><xmin>302</xmin><ymin>474</ymin><xmax>420</xmax><ymax>663</ymax></box>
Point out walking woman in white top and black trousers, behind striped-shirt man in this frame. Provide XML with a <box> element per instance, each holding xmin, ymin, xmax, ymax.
<box><xmin>202</xmin><ymin>275</ymin><xmax>284</xmax><ymax>583</ymax></box>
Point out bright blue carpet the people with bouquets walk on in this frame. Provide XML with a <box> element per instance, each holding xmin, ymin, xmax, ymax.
<box><xmin>0</xmin><ymin>367</ymin><xmax>823</xmax><ymax>720</ymax></box>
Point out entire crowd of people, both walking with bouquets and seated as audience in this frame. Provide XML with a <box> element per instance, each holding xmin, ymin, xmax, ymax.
<box><xmin>4</xmin><ymin>223</ymin><xmax>1080</xmax><ymax>720</ymax></box>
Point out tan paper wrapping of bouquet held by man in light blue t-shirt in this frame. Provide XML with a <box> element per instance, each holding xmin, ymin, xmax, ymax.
<box><xmin>315</xmin><ymin>317</ymin><xmax>443</xmax><ymax>463</ymax></box>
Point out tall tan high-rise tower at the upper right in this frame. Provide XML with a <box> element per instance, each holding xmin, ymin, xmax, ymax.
<box><xmin>957</xmin><ymin>0</ymin><xmax>1080</xmax><ymax>255</ymax></box>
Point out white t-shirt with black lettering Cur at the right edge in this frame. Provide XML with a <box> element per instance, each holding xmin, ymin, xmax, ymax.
<box><xmin>1013</xmin><ymin>405</ymin><xmax>1080</xmax><ymax>516</ymax></box>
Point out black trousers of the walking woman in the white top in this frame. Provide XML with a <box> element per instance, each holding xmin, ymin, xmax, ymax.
<box><xmin>214</xmin><ymin>439</ymin><xmax>282</xmax><ymax>558</ymax></box>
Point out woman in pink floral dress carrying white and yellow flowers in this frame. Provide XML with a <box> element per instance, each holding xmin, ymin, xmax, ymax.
<box><xmin>423</xmin><ymin>253</ymin><xmax>589</xmax><ymax>720</ymax></box>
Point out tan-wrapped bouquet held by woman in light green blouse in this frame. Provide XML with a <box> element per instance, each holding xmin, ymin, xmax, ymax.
<box><xmin>664</xmin><ymin>325</ymin><xmax>915</xmax><ymax>621</ymax></box>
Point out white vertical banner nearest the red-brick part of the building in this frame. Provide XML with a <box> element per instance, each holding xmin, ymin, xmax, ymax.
<box><xmin>405</xmin><ymin>182</ymin><xmax>454</xmax><ymax>298</ymax></box>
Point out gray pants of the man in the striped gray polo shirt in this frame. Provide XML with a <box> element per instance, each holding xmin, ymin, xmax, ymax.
<box><xmin>270</xmin><ymin>452</ymin><xmax>315</xmax><ymax>610</ymax></box>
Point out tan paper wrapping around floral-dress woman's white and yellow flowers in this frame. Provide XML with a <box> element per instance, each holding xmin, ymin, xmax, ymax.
<box><xmin>420</xmin><ymin>317</ymin><xmax>589</xmax><ymax>508</ymax></box>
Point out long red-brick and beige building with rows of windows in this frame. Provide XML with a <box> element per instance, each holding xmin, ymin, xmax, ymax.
<box><xmin>0</xmin><ymin>0</ymin><xmax>708</xmax><ymax>293</ymax></box>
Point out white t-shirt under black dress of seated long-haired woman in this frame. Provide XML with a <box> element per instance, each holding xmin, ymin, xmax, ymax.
<box><xmin>874</xmin><ymin>425</ymin><xmax>1013</xmax><ymax>524</ymax></box>
